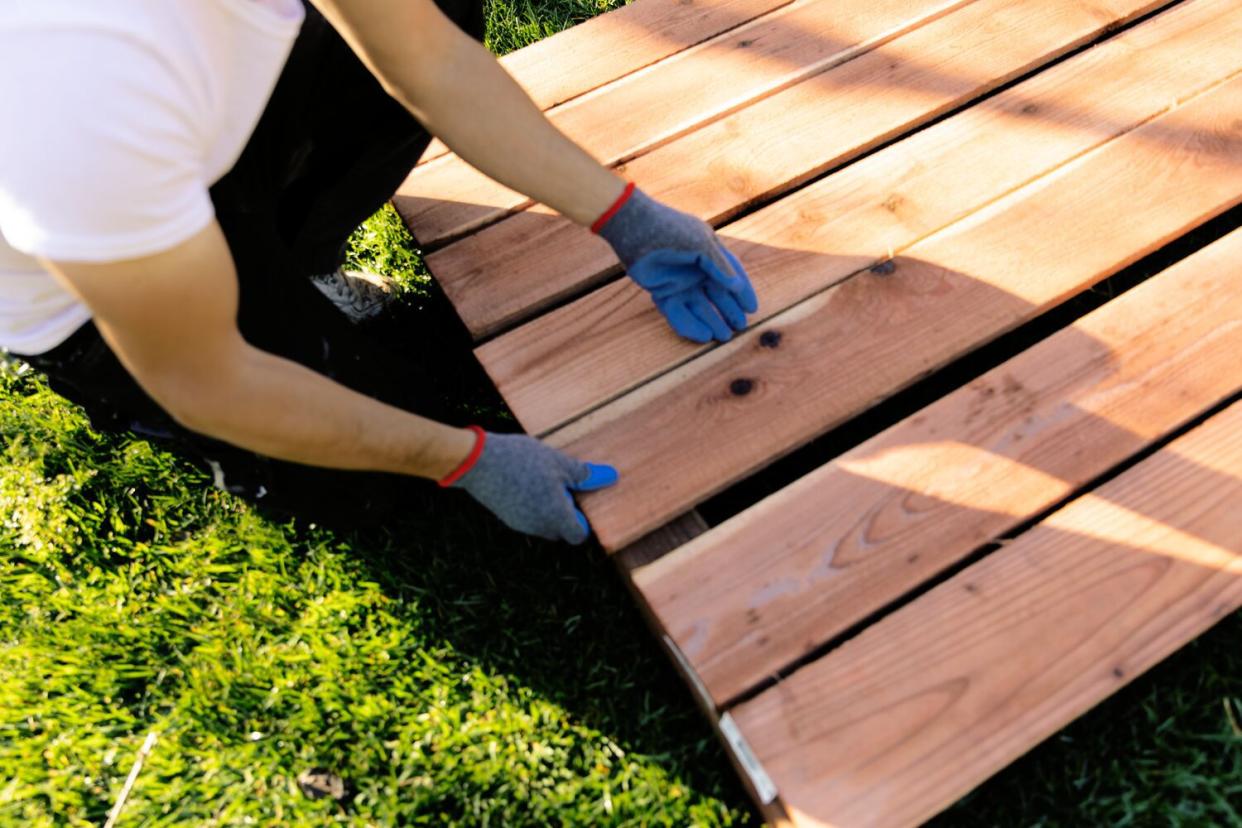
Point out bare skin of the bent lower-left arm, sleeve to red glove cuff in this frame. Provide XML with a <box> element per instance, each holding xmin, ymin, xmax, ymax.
<box><xmin>43</xmin><ymin>221</ymin><xmax>476</xmax><ymax>479</ymax></box>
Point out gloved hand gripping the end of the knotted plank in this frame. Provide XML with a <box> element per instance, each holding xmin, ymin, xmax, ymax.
<box><xmin>440</xmin><ymin>426</ymin><xmax>617</xmax><ymax>544</ymax></box>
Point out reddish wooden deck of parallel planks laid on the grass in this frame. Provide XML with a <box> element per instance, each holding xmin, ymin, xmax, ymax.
<box><xmin>395</xmin><ymin>0</ymin><xmax>1242</xmax><ymax>827</ymax></box>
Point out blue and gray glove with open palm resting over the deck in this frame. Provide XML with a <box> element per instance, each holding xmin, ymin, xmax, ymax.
<box><xmin>591</xmin><ymin>184</ymin><xmax>759</xmax><ymax>343</ymax></box>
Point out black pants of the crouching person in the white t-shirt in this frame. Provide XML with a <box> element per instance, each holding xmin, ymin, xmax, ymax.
<box><xmin>21</xmin><ymin>0</ymin><xmax>483</xmax><ymax>521</ymax></box>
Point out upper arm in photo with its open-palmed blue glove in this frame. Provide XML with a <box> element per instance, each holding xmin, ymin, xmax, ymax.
<box><xmin>313</xmin><ymin>0</ymin><xmax>758</xmax><ymax>343</ymax></box>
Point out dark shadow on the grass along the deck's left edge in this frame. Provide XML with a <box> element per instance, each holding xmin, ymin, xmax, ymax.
<box><xmin>227</xmin><ymin>286</ymin><xmax>759</xmax><ymax>824</ymax></box>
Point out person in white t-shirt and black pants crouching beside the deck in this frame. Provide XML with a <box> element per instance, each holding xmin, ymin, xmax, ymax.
<box><xmin>0</xmin><ymin>0</ymin><xmax>756</xmax><ymax>542</ymax></box>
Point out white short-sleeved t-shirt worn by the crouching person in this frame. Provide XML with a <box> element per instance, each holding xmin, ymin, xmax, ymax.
<box><xmin>0</xmin><ymin>0</ymin><xmax>304</xmax><ymax>354</ymax></box>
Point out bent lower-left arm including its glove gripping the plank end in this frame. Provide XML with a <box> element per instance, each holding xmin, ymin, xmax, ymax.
<box><xmin>42</xmin><ymin>221</ymin><xmax>617</xmax><ymax>544</ymax></box>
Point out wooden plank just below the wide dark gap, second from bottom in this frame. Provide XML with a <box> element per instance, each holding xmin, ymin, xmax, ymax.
<box><xmin>633</xmin><ymin>224</ymin><xmax>1242</xmax><ymax>706</ymax></box>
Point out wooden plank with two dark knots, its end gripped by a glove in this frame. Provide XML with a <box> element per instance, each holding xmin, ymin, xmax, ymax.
<box><xmin>549</xmin><ymin>71</ymin><xmax>1242</xmax><ymax>549</ymax></box>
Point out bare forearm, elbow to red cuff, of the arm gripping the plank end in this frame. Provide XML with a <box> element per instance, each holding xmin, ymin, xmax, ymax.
<box><xmin>177</xmin><ymin>348</ymin><xmax>474</xmax><ymax>480</ymax></box>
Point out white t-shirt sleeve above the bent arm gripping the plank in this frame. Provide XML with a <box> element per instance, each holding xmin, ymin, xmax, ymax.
<box><xmin>0</xmin><ymin>30</ymin><xmax>214</xmax><ymax>262</ymax></box>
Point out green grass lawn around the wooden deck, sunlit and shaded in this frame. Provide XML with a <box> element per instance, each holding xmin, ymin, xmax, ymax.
<box><xmin>0</xmin><ymin>0</ymin><xmax>1242</xmax><ymax>826</ymax></box>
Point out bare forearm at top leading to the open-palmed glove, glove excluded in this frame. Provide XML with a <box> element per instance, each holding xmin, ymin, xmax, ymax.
<box><xmin>319</xmin><ymin>0</ymin><xmax>625</xmax><ymax>225</ymax></box>
